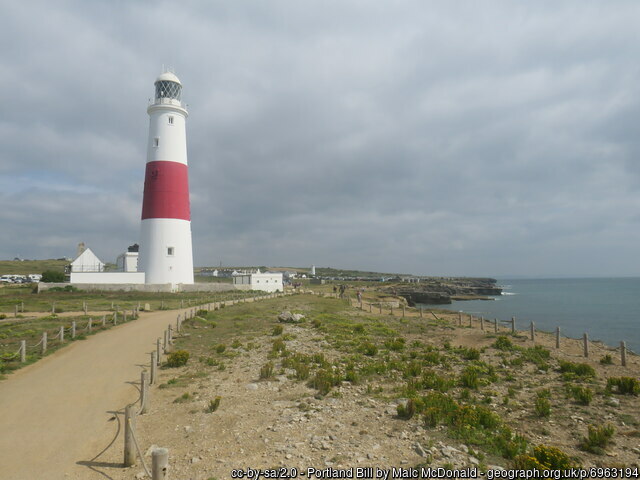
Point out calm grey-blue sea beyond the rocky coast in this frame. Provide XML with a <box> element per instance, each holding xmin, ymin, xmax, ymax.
<box><xmin>430</xmin><ymin>277</ymin><xmax>640</xmax><ymax>353</ymax></box>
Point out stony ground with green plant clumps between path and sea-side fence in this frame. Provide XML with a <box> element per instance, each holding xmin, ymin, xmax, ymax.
<box><xmin>107</xmin><ymin>295</ymin><xmax>640</xmax><ymax>480</ymax></box>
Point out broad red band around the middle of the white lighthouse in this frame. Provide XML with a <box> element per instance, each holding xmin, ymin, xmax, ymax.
<box><xmin>142</xmin><ymin>161</ymin><xmax>191</xmax><ymax>220</ymax></box>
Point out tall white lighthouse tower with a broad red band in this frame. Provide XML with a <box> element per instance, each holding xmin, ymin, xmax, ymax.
<box><xmin>138</xmin><ymin>72</ymin><xmax>193</xmax><ymax>285</ymax></box>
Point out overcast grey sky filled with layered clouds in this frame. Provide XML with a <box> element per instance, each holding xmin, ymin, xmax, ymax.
<box><xmin>0</xmin><ymin>0</ymin><xmax>640</xmax><ymax>276</ymax></box>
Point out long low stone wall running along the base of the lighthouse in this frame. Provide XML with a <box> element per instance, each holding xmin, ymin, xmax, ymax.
<box><xmin>38</xmin><ymin>282</ymin><xmax>242</xmax><ymax>293</ymax></box>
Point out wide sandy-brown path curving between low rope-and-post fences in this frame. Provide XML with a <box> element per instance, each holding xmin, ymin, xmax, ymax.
<box><xmin>0</xmin><ymin>310</ymin><xmax>178</xmax><ymax>480</ymax></box>
